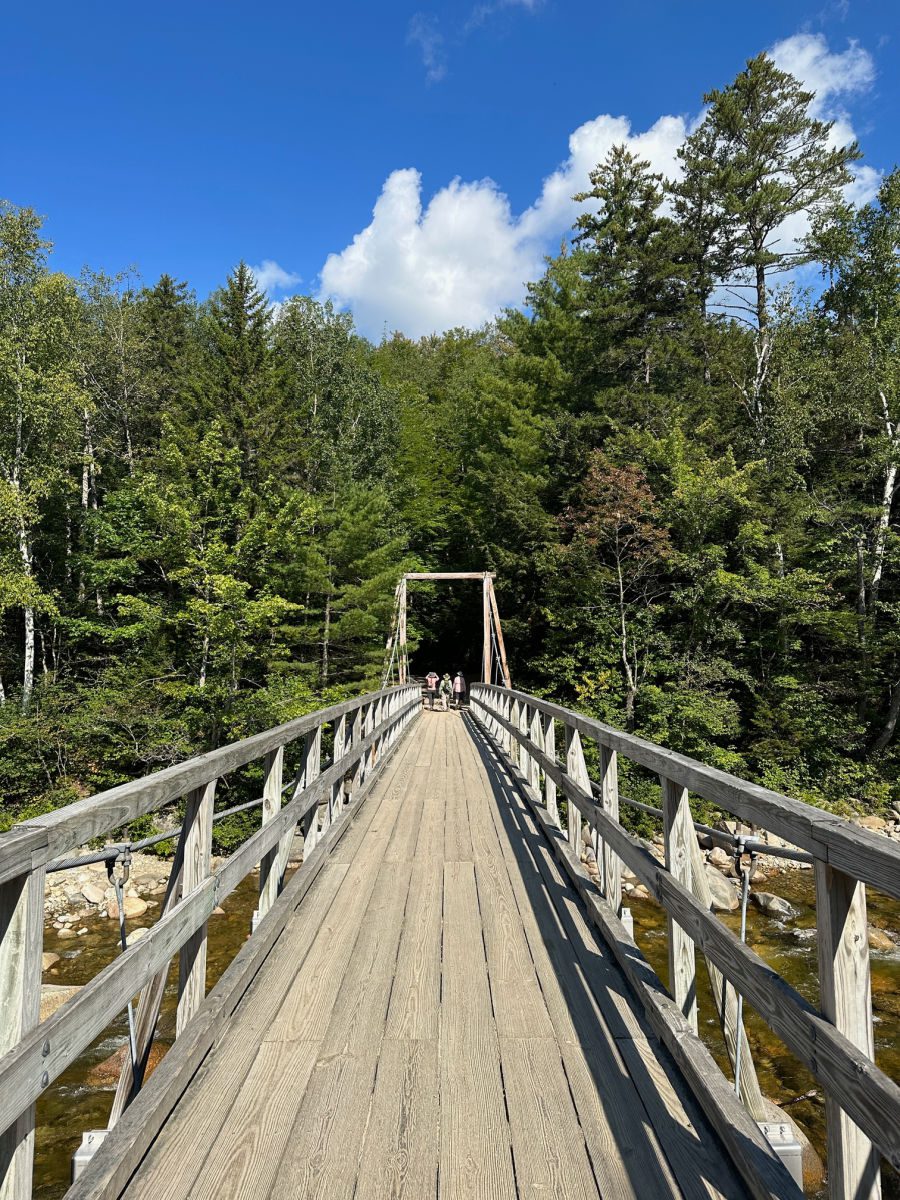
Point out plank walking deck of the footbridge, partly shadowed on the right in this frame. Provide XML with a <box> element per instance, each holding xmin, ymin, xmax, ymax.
<box><xmin>125</xmin><ymin>713</ymin><xmax>745</xmax><ymax>1200</ymax></box>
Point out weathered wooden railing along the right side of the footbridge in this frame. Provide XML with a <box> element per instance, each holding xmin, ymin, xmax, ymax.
<box><xmin>470</xmin><ymin>684</ymin><xmax>900</xmax><ymax>1200</ymax></box>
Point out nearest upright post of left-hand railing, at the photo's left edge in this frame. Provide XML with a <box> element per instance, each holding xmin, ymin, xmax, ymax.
<box><xmin>0</xmin><ymin>866</ymin><xmax>47</xmax><ymax>1200</ymax></box>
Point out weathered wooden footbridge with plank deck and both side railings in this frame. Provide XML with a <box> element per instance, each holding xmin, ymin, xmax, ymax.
<box><xmin>0</xmin><ymin>624</ymin><xmax>900</xmax><ymax>1200</ymax></box>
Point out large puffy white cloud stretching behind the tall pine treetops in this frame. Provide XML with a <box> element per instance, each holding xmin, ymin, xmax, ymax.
<box><xmin>320</xmin><ymin>34</ymin><xmax>878</xmax><ymax>337</ymax></box>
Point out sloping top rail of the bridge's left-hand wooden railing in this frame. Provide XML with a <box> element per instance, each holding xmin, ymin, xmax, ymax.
<box><xmin>0</xmin><ymin>686</ymin><xmax>403</xmax><ymax>883</ymax></box>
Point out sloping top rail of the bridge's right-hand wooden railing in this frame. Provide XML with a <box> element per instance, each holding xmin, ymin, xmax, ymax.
<box><xmin>472</xmin><ymin>683</ymin><xmax>900</xmax><ymax>900</ymax></box>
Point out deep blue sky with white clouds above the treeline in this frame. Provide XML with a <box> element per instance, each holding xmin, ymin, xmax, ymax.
<box><xmin>0</xmin><ymin>0</ymin><xmax>900</xmax><ymax>340</ymax></box>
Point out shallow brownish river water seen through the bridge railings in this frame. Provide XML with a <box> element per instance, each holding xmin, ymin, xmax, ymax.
<box><xmin>35</xmin><ymin>871</ymin><xmax>900</xmax><ymax>1200</ymax></box>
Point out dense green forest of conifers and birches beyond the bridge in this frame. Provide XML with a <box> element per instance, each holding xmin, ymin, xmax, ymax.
<box><xmin>0</xmin><ymin>55</ymin><xmax>900</xmax><ymax>829</ymax></box>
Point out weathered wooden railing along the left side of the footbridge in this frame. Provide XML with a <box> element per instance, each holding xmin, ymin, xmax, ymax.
<box><xmin>0</xmin><ymin>685</ymin><xmax>420</xmax><ymax>1200</ymax></box>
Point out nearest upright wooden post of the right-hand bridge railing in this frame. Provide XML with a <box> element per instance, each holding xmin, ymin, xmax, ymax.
<box><xmin>815</xmin><ymin>859</ymin><xmax>881</xmax><ymax>1200</ymax></box>
